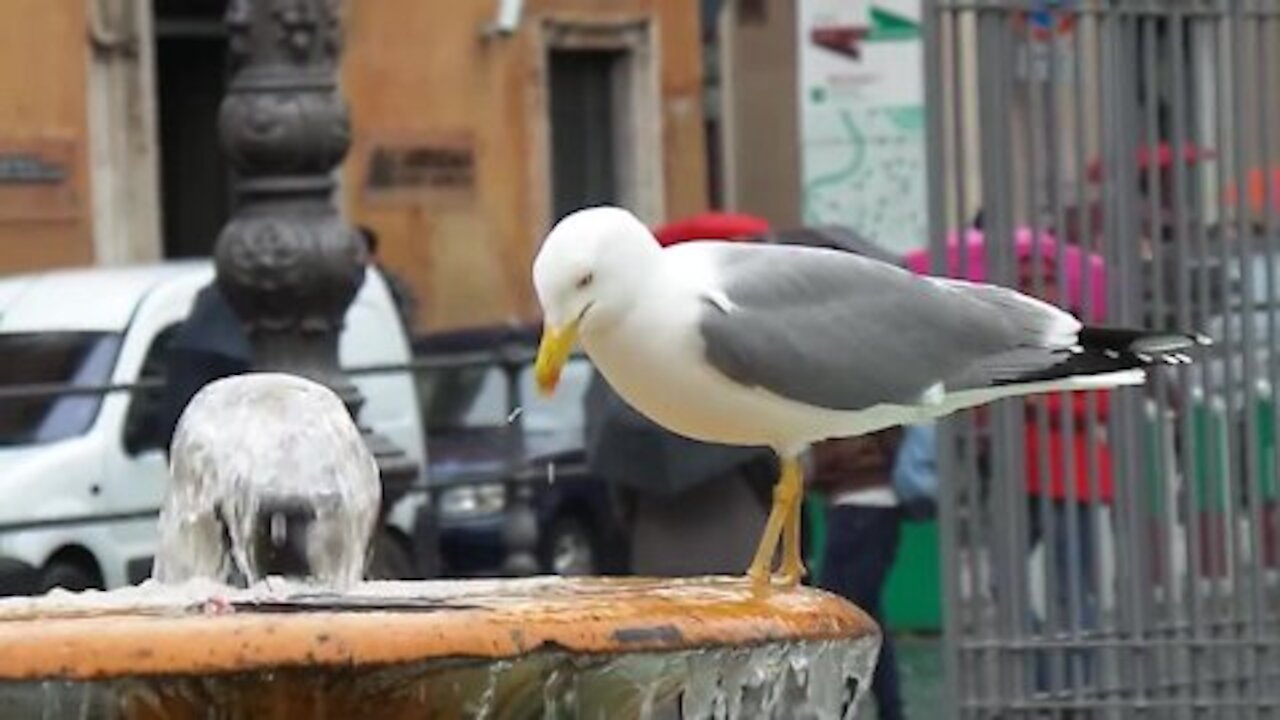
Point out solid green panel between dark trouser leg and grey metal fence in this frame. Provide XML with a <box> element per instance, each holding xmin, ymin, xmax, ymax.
<box><xmin>881</xmin><ymin>520</ymin><xmax>942</xmax><ymax>633</ymax></box>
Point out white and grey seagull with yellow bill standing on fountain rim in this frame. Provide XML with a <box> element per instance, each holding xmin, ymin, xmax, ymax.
<box><xmin>532</xmin><ymin>206</ymin><xmax>1208</xmax><ymax>587</ymax></box>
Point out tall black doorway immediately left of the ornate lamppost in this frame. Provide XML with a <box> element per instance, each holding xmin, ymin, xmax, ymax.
<box><xmin>155</xmin><ymin>0</ymin><xmax>232</xmax><ymax>258</ymax></box>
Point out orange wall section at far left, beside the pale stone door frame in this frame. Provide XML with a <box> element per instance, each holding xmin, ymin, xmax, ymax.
<box><xmin>0</xmin><ymin>0</ymin><xmax>93</xmax><ymax>273</ymax></box>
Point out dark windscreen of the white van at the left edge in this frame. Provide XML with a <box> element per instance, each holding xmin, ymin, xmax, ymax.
<box><xmin>0</xmin><ymin>332</ymin><xmax>120</xmax><ymax>446</ymax></box>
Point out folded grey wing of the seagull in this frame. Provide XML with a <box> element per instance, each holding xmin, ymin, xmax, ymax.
<box><xmin>699</xmin><ymin>243</ymin><xmax>1079</xmax><ymax>410</ymax></box>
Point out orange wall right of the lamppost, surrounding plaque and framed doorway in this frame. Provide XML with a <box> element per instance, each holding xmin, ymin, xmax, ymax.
<box><xmin>343</xmin><ymin>0</ymin><xmax>707</xmax><ymax>329</ymax></box>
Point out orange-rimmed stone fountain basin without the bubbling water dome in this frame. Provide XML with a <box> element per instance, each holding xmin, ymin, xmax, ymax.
<box><xmin>0</xmin><ymin>578</ymin><xmax>879</xmax><ymax>719</ymax></box>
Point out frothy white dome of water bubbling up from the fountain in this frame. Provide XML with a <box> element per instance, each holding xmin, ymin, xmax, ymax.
<box><xmin>154</xmin><ymin>373</ymin><xmax>381</xmax><ymax>589</ymax></box>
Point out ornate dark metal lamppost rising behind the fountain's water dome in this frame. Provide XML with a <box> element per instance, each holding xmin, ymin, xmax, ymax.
<box><xmin>215</xmin><ymin>0</ymin><xmax>417</xmax><ymax>558</ymax></box>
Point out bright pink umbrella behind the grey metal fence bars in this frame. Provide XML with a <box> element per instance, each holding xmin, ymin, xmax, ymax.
<box><xmin>905</xmin><ymin>228</ymin><xmax>1107</xmax><ymax>323</ymax></box>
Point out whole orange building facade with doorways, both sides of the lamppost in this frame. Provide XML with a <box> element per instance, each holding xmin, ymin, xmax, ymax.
<box><xmin>0</xmin><ymin>0</ymin><xmax>707</xmax><ymax>328</ymax></box>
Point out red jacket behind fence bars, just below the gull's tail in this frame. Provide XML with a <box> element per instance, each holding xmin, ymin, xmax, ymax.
<box><xmin>1023</xmin><ymin>392</ymin><xmax>1115</xmax><ymax>502</ymax></box>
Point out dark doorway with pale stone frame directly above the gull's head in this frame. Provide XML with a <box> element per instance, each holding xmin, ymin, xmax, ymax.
<box><xmin>548</xmin><ymin>50</ymin><xmax>625</xmax><ymax>220</ymax></box>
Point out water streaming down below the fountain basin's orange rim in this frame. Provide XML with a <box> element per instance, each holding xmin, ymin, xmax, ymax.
<box><xmin>0</xmin><ymin>637</ymin><xmax>878</xmax><ymax>720</ymax></box>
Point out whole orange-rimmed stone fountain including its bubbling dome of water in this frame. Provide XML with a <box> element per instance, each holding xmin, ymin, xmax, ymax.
<box><xmin>0</xmin><ymin>373</ymin><xmax>879</xmax><ymax>720</ymax></box>
